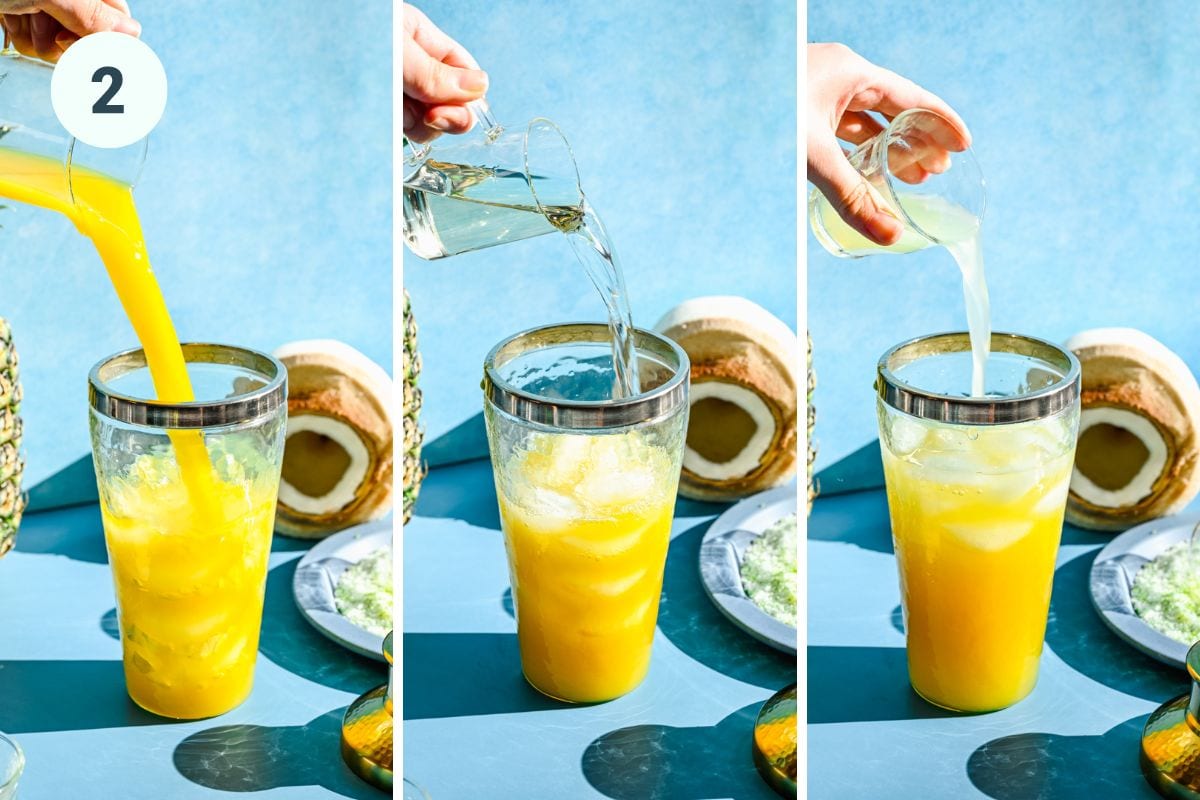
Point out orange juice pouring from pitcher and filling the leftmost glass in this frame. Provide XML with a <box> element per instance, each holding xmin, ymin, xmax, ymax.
<box><xmin>0</xmin><ymin>148</ymin><xmax>276</xmax><ymax>718</ymax></box>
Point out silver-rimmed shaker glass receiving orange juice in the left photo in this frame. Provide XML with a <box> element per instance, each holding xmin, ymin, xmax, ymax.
<box><xmin>89</xmin><ymin>344</ymin><xmax>287</xmax><ymax>720</ymax></box>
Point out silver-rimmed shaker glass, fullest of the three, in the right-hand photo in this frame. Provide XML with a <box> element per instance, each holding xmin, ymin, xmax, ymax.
<box><xmin>876</xmin><ymin>332</ymin><xmax>1080</xmax><ymax>711</ymax></box>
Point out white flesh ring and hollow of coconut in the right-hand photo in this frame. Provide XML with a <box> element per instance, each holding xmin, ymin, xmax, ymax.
<box><xmin>1070</xmin><ymin>407</ymin><xmax>1168</xmax><ymax>509</ymax></box>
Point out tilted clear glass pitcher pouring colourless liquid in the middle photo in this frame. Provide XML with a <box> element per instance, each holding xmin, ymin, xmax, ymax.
<box><xmin>403</xmin><ymin>103</ymin><xmax>583</xmax><ymax>259</ymax></box>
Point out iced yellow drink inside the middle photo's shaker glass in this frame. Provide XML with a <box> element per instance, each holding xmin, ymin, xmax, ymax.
<box><xmin>497</xmin><ymin>432</ymin><xmax>679</xmax><ymax>703</ymax></box>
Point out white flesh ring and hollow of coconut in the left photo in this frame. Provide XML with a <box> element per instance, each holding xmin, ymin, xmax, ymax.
<box><xmin>280</xmin><ymin>414</ymin><xmax>371</xmax><ymax>516</ymax></box>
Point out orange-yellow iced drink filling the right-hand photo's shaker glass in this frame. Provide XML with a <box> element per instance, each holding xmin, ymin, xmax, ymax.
<box><xmin>881</xmin><ymin>408</ymin><xmax>1078</xmax><ymax>711</ymax></box>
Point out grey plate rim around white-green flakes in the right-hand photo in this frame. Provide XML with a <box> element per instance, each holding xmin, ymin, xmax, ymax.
<box><xmin>1088</xmin><ymin>515</ymin><xmax>1200</xmax><ymax>669</ymax></box>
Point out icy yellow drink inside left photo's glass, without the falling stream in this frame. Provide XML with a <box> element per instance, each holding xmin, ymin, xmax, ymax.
<box><xmin>101</xmin><ymin>445</ymin><xmax>278</xmax><ymax>720</ymax></box>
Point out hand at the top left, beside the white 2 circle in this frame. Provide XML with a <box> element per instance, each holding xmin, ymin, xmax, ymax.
<box><xmin>0</xmin><ymin>0</ymin><xmax>142</xmax><ymax>62</ymax></box>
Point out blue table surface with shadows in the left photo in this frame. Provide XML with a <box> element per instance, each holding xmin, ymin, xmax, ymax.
<box><xmin>0</xmin><ymin>505</ymin><xmax>388</xmax><ymax>800</ymax></box>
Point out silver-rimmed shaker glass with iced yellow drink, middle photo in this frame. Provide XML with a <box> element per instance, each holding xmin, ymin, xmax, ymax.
<box><xmin>484</xmin><ymin>324</ymin><xmax>690</xmax><ymax>703</ymax></box>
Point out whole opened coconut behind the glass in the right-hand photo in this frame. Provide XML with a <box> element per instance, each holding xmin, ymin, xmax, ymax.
<box><xmin>1066</xmin><ymin>327</ymin><xmax>1200</xmax><ymax>530</ymax></box>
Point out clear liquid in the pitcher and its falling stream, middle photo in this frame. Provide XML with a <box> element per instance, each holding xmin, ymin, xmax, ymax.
<box><xmin>404</xmin><ymin>160</ymin><xmax>641</xmax><ymax>398</ymax></box>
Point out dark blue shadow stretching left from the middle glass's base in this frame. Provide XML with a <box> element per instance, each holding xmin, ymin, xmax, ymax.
<box><xmin>402</xmin><ymin>633</ymin><xmax>572</xmax><ymax>720</ymax></box>
